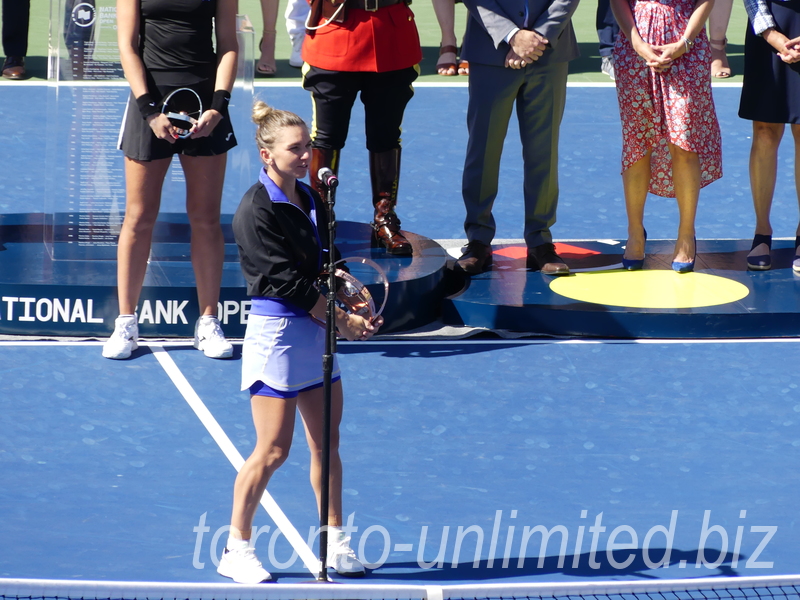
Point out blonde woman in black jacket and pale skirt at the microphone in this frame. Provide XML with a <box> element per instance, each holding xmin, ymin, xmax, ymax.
<box><xmin>218</xmin><ymin>101</ymin><xmax>382</xmax><ymax>583</ymax></box>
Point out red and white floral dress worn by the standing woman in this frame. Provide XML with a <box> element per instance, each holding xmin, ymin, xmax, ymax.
<box><xmin>614</xmin><ymin>0</ymin><xmax>722</xmax><ymax>198</ymax></box>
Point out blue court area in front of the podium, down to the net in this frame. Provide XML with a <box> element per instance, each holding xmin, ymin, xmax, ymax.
<box><xmin>0</xmin><ymin>341</ymin><xmax>800</xmax><ymax>584</ymax></box>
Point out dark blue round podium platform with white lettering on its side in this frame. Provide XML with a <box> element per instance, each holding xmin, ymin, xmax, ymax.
<box><xmin>0</xmin><ymin>213</ymin><xmax>447</xmax><ymax>337</ymax></box>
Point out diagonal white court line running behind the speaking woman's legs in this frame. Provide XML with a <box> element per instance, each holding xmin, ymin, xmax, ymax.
<box><xmin>150</xmin><ymin>344</ymin><xmax>319</xmax><ymax>576</ymax></box>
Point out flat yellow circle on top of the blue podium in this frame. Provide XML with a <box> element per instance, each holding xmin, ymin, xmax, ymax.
<box><xmin>550</xmin><ymin>270</ymin><xmax>750</xmax><ymax>308</ymax></box>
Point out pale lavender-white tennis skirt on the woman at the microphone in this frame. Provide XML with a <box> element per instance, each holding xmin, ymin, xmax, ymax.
<box><xmin>242</xmin><ymin>313</ymin><xmax>340</xmax><ymax>392</ymax></box>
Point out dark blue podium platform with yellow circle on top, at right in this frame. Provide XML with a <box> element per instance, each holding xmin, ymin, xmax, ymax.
<box><xmin>442</xmin><ymin>239</ymin><xmax>800</xmax><ymax>339</ymax></box>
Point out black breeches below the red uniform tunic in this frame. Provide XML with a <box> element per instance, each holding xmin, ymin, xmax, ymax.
<box><xmin>303</xmin><ymin>67</ymin><xmax>418</xmax><ymax>152</ymax></box>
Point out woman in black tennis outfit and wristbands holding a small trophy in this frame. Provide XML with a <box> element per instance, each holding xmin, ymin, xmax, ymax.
<box><xmin>103</xmin><ymin>0</ymin><xmax>238</xmax><ymax>359</ymax></box>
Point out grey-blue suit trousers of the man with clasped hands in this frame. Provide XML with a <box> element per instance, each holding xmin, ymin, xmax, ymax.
<box><xmin>462</xmin><ymin>62</ymin><xmax>568</xmax><ymax>248</ymax></box>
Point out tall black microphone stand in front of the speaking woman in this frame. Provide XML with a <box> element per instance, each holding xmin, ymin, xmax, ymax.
<box><xmin>317</xmin><ymin>172</ymin><xmax>337</xmax><ymax>582</ymax></box>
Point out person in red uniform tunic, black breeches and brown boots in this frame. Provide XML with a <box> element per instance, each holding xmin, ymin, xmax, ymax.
<box><xmin>303</xmin><ymin>0</ymin><xmax>422</xmax><ymax>255</ymax></box>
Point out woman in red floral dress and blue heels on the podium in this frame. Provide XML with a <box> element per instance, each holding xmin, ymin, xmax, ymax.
<box><xmin>611</xmin><ymin>0</ymin><xmax>722</xmax><ymax>273</ymax></box>
